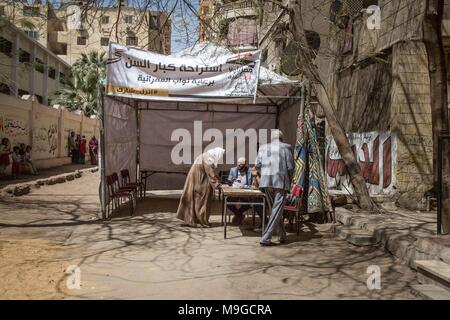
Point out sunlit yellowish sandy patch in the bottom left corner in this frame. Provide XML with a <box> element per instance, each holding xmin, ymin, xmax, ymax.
<box><xmin>0</xmin><ymin>238</ymin><xmax>67</xmax><ymax>300</ymax></box>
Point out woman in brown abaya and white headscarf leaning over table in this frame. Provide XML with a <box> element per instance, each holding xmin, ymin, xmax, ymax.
<box><xmin>177</xmin><ymin>148</ymin><xmax>225</xmax><ymax>227</ymax></box>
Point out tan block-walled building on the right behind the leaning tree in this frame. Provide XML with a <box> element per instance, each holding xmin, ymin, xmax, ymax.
<box><xmin>326</xmin><ymin>0</ymin><xmax>450</xmax><ymax>209</ymax></box>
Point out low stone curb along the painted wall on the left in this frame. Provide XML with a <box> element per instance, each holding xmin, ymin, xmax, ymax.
<box><xmin>1</xmin><ymin>167</ymin><xmax>98</xmax><ymax>197</ymax></box>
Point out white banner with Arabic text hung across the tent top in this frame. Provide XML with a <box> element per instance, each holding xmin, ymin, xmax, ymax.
<box><xmin>106</xmin><ymin>43</ymin><xmax>260</xmax><ymax>101</ymax></box>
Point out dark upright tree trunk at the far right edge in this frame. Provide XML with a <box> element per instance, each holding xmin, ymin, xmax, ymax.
<box><xmin>423</xmin><ymin>0</ymin><xmax>450</xmax><ymax>233</ymax></box>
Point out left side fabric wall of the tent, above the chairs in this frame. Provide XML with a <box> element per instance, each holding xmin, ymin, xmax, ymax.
<box><xmin>104</xmin><ymin>97</ymin><xmax>138</xmax><ymax>181</ymax></box>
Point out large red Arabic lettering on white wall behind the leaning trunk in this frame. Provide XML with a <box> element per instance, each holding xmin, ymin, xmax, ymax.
<box><xmin>325</xmin><ymin>132</ymin><xmax>397</xmax><ymax>195</ymax></box>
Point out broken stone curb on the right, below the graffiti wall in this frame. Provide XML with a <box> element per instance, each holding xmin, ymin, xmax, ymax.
<box><xmin>334</xmin><ymin>207</ymin><xmax>450</xmax><ymax>270</ymax></box>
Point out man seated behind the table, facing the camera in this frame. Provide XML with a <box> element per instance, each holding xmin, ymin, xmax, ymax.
<box><xmin>228</xmin><ymin>157</ymin><xmax>252</xmax><ymax>225</ymax></box>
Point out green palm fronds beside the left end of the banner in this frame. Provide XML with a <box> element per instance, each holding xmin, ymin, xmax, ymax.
<box><xmin>52</xmin><ymin>51</ymin><xmax>106</xmax><ymax>117</ymax></box>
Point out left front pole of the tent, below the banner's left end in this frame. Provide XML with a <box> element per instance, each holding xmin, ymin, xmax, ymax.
<box><xmin>97</xmin><ymin>85</ymin><xmax>108</xmax><ymax>220</ymax></box>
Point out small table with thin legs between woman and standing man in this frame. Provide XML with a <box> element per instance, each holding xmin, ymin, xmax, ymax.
<box><xmin>221</xmin><ymin>186</ymin><xmax>266</xmax><ymax>239</ymax></box>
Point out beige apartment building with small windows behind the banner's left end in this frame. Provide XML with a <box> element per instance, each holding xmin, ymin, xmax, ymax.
<box><xmin>48</xmin><ymin>2</ymin><xmax>171</xmax><ymax>64</ymax></box>
